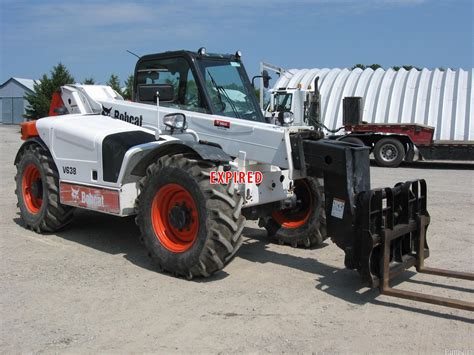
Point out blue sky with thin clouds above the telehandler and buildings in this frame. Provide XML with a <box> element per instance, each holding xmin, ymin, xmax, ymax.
<box><xmin>0</xmin><ymin>0</ymin><xmax>474</xmax><ymax>83</ymax></box>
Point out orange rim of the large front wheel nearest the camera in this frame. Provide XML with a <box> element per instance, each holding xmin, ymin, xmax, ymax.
<box><xmin>151</xmin><ymin>184</ymin><xmax>199</xmax><ymax>253</ymax></box>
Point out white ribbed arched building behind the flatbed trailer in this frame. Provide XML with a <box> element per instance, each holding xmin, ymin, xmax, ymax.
<box><xmin>274</xmin><ymin>68</ymin><xmax>474</xmax><ymax>141</ymax></box>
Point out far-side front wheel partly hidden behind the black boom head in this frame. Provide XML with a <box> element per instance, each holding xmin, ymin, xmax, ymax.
<box><xmin>263</xmin><ymin>177</ymin><xmax>327</xmax><ymax>247</ymax></box>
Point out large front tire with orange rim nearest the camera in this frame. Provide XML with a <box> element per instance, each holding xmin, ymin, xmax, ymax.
<box><xmin>136</xmin><ymin>154</ymin><xmax>245</xmax><ymax>279</ymax></box>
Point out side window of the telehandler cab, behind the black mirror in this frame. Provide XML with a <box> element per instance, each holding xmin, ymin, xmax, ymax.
<box><xmin>136</xmin><ymin>58</ymin><xmax>207</xmax><ymax>112</ymax></box>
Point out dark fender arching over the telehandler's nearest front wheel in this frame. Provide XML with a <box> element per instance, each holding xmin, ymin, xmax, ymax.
<box><xmin>122</xmin><ymin>140</ymin><xmax>232</xmax><ymax>183</ymax></box>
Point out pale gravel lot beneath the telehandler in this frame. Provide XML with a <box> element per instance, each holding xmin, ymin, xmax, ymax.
<box><xmin>0</xmin><ymin>125</ymin><xmax>474</xmax><ymax>354</ymax></box>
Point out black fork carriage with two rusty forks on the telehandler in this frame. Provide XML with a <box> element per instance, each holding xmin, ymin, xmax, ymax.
<box><xmin>360</xmin><ymin>180</ymin><xmax>474</xmax><ymax>311</ymax></box>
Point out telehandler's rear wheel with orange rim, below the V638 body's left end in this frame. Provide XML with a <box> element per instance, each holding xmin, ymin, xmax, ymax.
<box><xmin>15</xmin><ymin>144</ymin><xmax>74</xmax><ymax>233</ymax></box>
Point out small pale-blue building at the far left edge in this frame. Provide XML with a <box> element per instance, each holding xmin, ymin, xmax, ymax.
<box><xmin>0</xmin><ymin>78</ymin><xmax>35</xmax><ymax>124</ymax></box>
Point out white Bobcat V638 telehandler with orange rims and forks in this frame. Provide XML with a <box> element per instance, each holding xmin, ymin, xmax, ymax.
<box><xmin>15</xmin><ymin>48</ymin><xmax>474</xmax><ymax>310</ymax></box>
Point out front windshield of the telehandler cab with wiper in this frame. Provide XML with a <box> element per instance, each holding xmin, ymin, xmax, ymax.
<box><xmin>197</xmin><ymin>59</ymin><xmax>264</xmax><ymax>122</ymax></box>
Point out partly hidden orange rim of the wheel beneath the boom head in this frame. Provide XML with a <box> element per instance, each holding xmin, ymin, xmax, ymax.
<box><xmin>272</xmin><ymin>180</ymin><xmax>313</xmax><ymax>229</ymax></box>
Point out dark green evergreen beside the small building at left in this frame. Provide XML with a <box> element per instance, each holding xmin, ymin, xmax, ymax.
<box><xmin>23</xmin><ymin>63</ymin><xmax>74</xmax><ymax>120</ymax></box>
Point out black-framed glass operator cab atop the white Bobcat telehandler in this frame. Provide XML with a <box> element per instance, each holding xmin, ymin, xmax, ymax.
<box><xmin>133</xmin><ymin>48</ymin><xmax>265</xmax><ymax>122</ymax></box>
